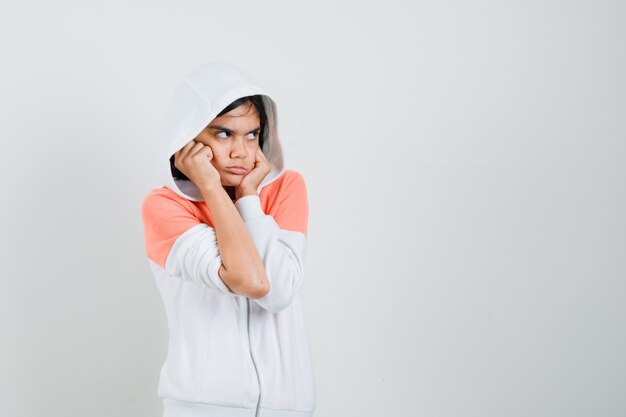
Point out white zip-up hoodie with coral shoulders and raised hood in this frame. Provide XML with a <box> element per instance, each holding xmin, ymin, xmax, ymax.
<box><xmin>141</xmin><ymin>61</ymin><xmax>315</xmax><ymax>417</ymax></box>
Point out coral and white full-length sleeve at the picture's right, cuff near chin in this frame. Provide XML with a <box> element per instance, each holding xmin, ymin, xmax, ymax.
<box><xmin>235</xmin><ymin>171</ymin><xmax>308</xmax><ymax>313</ymax></box>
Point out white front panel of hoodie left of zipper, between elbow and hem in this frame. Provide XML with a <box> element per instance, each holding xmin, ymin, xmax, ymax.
<box><xmin>160</xmin><ymin>282</ymin><xmax>259</xmax><ymax>408</ymax></box>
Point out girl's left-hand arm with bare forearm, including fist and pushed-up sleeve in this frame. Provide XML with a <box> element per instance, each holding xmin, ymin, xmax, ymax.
<box><xmin>142</xmin><ymin>140</ymin><xmax>269</xmax><ymax>298</ymax></box>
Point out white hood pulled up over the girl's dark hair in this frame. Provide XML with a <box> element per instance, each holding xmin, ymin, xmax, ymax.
<box><xmin>156</xmin><ymin>61</ymin><xmax>283</xmax><ymax>201</ymax></box>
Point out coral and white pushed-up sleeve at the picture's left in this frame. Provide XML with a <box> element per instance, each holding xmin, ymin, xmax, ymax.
<box><xmin>141</xmin><ymin>189</ymin><xmax>236</xmax><ymax>296</ymax></box>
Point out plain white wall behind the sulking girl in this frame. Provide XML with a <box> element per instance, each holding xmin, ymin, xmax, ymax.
<box><xmin>0</xmin><ymin>0</ymin><xmax>626</xmax><ymax>417</ymax></box>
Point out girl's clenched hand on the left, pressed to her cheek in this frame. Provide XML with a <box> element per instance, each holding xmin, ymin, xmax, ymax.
<box><xmin>174</xmin><ymin>139</ymin><xmax>221</xmax><ymax>189</ymax></box>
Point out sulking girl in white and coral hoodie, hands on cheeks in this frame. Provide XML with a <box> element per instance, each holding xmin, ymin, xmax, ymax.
<box><xmin>141</xmin><ymin>61</ymin><xmax>315</xmax><ymax>417</ymax></box>
